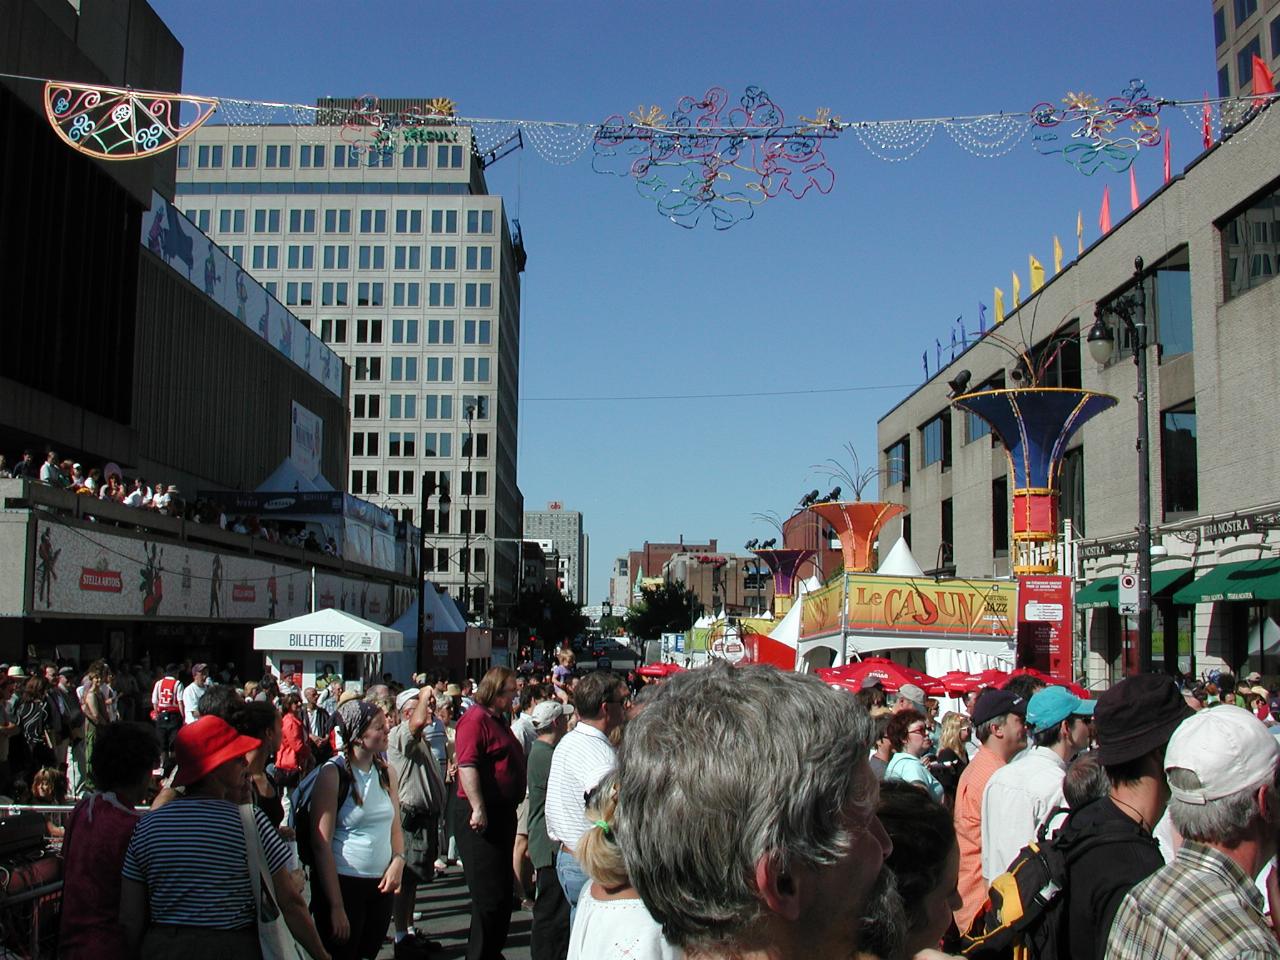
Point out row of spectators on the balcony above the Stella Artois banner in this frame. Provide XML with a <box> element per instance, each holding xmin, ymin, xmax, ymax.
<box><xmin>0</xmin><ymin>449</ymin><xmax>338</xmax><ymax>556</ymax></box>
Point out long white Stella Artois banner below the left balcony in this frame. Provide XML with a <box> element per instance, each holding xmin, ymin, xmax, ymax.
<box><xmin>31</xmin><ymin>520</ymin><xmax>399</xmax><ymax>623</ymax></box>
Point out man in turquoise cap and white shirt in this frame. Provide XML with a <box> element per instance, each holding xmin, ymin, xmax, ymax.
<box><xmin>982</xmin><ymin>686</ymin><xmax>1097</xmax><ymax>884</ymax></box>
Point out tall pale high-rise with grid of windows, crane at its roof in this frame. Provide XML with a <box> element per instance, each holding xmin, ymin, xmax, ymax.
<box><xmin>177</xmin><ymin>99</ymin><xmax>525</xmax><ymax>621</ymax></box>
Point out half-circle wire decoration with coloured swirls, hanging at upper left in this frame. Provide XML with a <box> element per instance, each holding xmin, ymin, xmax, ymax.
<box><xmin>45</xmin><ymin>81</ymin><xmax>218</xmax><ymax>160</ymax></box>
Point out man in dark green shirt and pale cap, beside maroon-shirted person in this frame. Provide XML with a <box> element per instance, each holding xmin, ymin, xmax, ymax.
<box><xmin>526</xmin><ymin>699</ymin><xmax>572</xmax><ymax>960</ymax></box>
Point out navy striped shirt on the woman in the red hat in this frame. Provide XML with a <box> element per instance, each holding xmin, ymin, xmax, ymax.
<box><xmin>122</xmin><ymin>797</ymin><xmax>289</xmax><ymax>931</ymax></box>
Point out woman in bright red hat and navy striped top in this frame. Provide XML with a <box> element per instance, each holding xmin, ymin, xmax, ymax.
<box><xmin>120</xmin><ymin>716</ymin><xmax>330</xmax><ymax>960</ymax></box>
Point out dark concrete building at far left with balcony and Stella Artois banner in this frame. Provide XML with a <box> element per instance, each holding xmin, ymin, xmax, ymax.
<box><xmin>0</xmin><ymin>0</ymin><xmax>412</xmax><ymax>676</ymax></box>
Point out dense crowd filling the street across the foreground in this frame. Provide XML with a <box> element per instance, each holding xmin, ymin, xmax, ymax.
<box><xmin>17</xmin><ymin>652</ymin><xmax>1280</xmax><ymax>960</ymax></box>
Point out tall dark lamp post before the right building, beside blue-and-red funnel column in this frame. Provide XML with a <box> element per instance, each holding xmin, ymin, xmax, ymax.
<box><xmin>1087</xmin><ymin>257</ymin><xmax>1151</xmax><ymax>672</ymax></box>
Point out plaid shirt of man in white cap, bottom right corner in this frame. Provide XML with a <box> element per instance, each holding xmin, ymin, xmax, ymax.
<box><xmin>1107</xmin><ymin>840</ymin><xmax>1280</xmax><ymax>960</ymax></box>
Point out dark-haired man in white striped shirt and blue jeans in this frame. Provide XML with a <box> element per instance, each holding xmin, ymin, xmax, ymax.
<box><xmin>547</xmin><ymin>669</ymin><xmax>630</xmax><ymax>913</ymax></box>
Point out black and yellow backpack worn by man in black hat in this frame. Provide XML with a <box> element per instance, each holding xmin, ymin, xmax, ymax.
<box><xmin>960</xmin><ymin>806</ymin><xmax>1156</xmax><ymax>960</ymax></box>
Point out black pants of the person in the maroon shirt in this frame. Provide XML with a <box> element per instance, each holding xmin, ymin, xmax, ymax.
<box><xmin>453</xmin><ymin>800</ymin><xmax>516</xmax><ymax>960</ymax></box>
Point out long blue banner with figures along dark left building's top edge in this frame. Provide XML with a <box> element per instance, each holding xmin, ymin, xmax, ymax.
<box><xmin>142</xmin><ymin>191</ymin><xmax>343</xmax><ymax>397</ymax></box>
